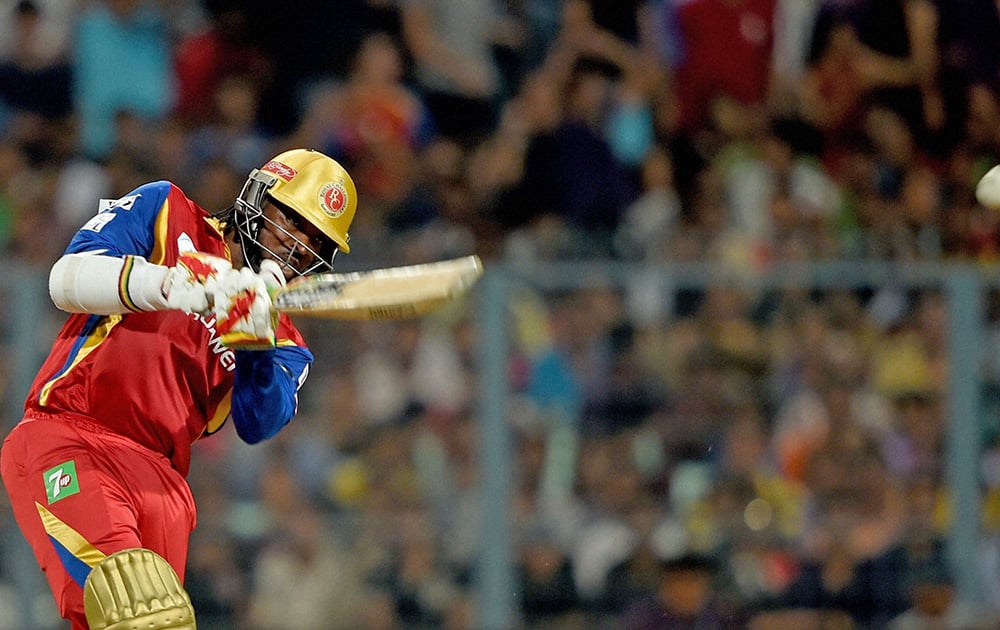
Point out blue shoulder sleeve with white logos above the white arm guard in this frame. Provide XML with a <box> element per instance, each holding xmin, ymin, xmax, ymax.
<box><xmin>65</xmin><ymin>181</ymin><xmax>171</xmax><ymax>256</ymax></box>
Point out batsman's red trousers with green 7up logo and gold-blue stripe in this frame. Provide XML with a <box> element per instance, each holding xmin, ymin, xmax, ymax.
<box><xmin>0</xmin><ymin>412</ymin><xmax>196</xmax><ymax>630</ymax></box>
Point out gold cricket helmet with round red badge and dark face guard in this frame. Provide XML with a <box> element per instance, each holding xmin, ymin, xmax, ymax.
<box><xmin>232</xmin><ymin>149</ymin><xmax>357</xmax><ymax>276</ymax></box>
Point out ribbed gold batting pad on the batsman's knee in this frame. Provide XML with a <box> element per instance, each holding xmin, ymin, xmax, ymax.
<box><xmin>83</xmin><ymin>549</ymin><xmax>195</xmax><ymax>630</ymax></box>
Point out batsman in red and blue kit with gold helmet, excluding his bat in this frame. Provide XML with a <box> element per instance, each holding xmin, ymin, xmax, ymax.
<box><xmin>0</xmin><ymin>149</ymin><xmax>357</xmax><ymax>630</ymax></box>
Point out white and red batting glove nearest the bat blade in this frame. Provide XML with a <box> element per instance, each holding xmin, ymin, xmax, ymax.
<box><xmin>215</xmin><ymin>260</ymin><xmax>285</xmax><ymax>350</ymax></box>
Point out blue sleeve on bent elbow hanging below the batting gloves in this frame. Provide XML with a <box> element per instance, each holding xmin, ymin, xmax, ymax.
<box><xmin>232</xmin><ymin>346</ymin><xmax>313</xmax><ymax>444</ymax></box>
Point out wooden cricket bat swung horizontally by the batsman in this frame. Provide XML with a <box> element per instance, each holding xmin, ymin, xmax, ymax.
<box><xmin>272</xmin><ymin>255</ymin><xmax>483</xmax><ymax>320</ymax></box>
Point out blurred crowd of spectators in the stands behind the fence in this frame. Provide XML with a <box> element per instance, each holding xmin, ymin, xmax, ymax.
<box><xmin>0</xmin><ymin>0</ymin><xmax>1000</xmax><ymax>630</ymax></box>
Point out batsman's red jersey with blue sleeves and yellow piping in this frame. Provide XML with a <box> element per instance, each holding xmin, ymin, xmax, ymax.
<box><xmin>25</xmin><ymin>181</ymin><xmax>312</xmax><ymax>475</ymax></box>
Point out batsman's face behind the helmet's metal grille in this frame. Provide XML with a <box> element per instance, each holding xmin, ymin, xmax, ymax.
<box><xmin>257</xmin><ymin>199</ymin><xmax>330</xmax><ymax>279</ymax></box>
